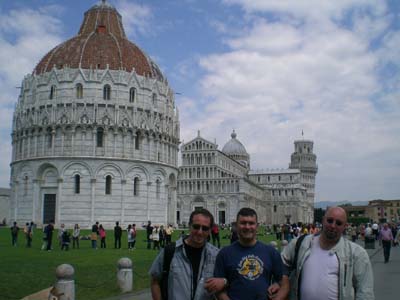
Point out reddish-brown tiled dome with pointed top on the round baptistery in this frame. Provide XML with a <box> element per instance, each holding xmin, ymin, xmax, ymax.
<box><xmin>34</xmin><ymin>0</ymin><xmax>164</xmax><ymax>81</ymax></box>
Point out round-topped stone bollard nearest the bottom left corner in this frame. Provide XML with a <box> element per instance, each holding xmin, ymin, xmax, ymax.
<box><xmin>54</xmin><ymin>264</ymin><xmax>75</xmax><ymax>300</ymax></box>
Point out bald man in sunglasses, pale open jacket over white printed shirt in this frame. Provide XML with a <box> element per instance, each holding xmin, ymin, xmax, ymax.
<box><xmin>282</xmin><ymin>207</ymin><xmax>374</xmax><ymax>300</ymax></box>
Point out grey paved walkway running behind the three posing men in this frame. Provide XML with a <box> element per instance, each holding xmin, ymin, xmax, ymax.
<box><xmin>107</xmin><ymin>242</ymin><xmax>400</xmax><ymax>300</ymax></box>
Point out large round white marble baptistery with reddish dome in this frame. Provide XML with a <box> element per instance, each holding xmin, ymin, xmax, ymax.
<box><xmin>9</xmin><ymin>1</ymin><xmax>180</xmax><ymax>228</ymax></box>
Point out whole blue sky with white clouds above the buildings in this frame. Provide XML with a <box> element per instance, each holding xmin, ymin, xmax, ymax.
<box><xmin>0</xmin><ymin>0</ymin><xmax>400</xmax><ymax>201</ymax></box>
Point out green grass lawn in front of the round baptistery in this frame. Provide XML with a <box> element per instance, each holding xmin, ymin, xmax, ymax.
<box><xmin>0</xmin><ymin>227</ymin><xmax>273</xmax><ymax>300</ymax></box>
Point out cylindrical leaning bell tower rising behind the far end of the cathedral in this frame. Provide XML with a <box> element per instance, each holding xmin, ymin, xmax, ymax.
<box><xmin>289</xmin><ymin>140</ymin><xmax>318</xmax><ymax>222</ymax></box>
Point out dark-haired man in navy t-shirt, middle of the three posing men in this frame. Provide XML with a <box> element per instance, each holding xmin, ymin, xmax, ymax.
<box><xmin>214</xmin><ymin>208</ymin><xmax>289</xmax><ymax>300</ymax></box>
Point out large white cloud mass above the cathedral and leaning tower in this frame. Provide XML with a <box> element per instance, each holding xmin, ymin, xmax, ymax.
<box><xmin>176</xmin><ymin>0</ymin><xmax>400</xmax><ymax>200</ymax></box>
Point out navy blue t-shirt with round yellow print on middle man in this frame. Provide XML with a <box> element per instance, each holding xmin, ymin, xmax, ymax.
<box><xmin>214</xmin><ymin>241</ymin><xmax>283</xmax><ymax>300</ymax></box>
